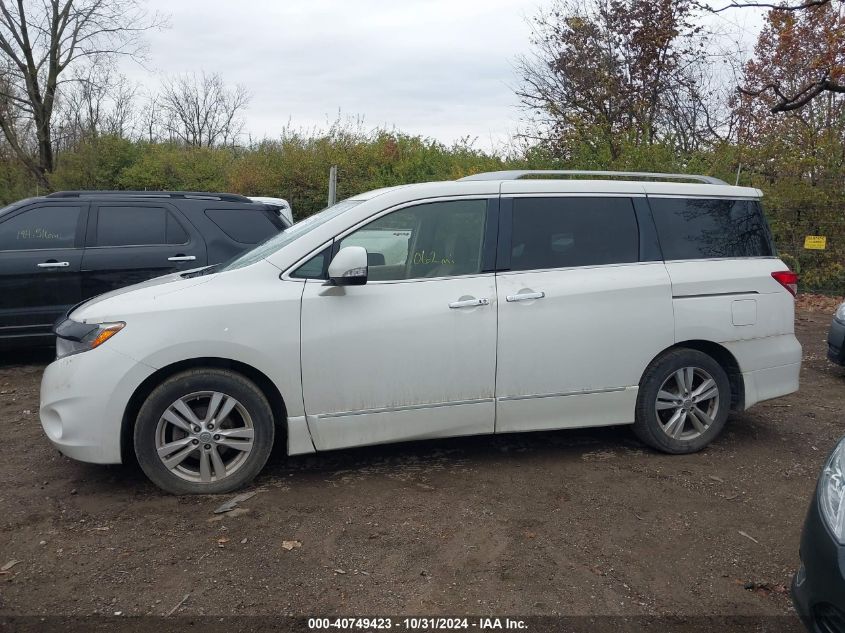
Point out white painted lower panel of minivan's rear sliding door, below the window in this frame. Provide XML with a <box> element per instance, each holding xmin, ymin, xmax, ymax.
<box><xmin>496</xmin><ymin>262</ymin><xmax>674</xmax><ymax>431</ymax></box>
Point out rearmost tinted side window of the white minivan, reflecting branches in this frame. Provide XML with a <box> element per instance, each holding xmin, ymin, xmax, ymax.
<box><xmin>649</xmin><ymin>198</ymin><xmax>774</xmax><ymax>260</ymax></box>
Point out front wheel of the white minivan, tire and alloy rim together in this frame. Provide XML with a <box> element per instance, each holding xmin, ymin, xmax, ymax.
<box><xmin>134</xmin><ymin>368</ymin><xmax>275</xmax><ymax>495</ymax></box>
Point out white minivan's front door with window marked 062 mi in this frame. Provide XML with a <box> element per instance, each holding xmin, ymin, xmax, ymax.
<box><xmin>301</xmin><ymin>199</ymin><xmax>497</xmax><ymax>450</ymax></box>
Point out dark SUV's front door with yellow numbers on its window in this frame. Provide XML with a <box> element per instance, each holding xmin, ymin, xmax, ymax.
<box><xmin>0</xmin><ymin>201</ymin><xmax>88</xmax><ymax>340</ymax></box>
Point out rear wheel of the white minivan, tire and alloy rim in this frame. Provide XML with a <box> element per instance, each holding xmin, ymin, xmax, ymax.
<box><xmin>634</xmin><ymin>349</ymin><xmax>731</xmax><ymax>455</ymax></box>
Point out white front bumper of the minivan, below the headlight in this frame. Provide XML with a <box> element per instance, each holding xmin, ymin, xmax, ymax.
<box><xmin>39</xmin><ymin>344</ymin><xmax>154</xmax><ymax>464</ymax></box>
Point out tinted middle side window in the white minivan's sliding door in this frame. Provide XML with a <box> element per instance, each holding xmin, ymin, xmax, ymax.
<box><xmin>511</xmin><ymin>198</ymin><xmax>639</xmax><ymax>270</ymax></box>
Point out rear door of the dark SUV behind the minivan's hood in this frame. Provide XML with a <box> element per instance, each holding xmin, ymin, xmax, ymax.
<box><xmin>82</xmin><ymin>202</ymin><xmax>206</xmax><ymax>299</ymax></box>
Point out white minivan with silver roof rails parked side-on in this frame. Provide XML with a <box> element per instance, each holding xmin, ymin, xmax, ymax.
<box><xmin>40</xmin><ymin>171</ymin><xmax>801</xmax><ymax>494</ymax></box>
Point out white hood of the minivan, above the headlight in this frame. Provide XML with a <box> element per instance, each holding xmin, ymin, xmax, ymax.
<box><xmin>68</xmin><ymin>269</ymin><xmax>217</xmax><ymax>323</ymax></box>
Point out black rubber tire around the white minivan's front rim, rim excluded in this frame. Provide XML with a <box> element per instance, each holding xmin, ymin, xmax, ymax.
<box><xmin>134</xmin><ymin>369</ymin><xmax>275</xmax><ymax>494</ymax></box>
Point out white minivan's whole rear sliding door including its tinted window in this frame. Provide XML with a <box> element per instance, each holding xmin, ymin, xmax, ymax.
<box><xmin>496</xmin><ymin>197</ymin><xmax>674</xmax><ymax>432</ymax></box>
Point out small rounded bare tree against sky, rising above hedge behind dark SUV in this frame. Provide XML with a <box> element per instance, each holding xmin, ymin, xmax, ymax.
<box><xmin>158</xmin><ymin>73</ymin><xmax>250</xmax><ymax>147</ymax></box>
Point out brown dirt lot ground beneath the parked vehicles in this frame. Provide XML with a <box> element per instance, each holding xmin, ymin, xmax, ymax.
<box><xmin>0</xmin><ymin>308</ymin><xmax>845</xmax><ymax>630</ymax></box>
